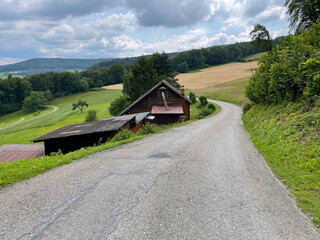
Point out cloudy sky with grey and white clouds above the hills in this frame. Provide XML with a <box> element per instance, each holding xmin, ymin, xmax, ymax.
<box><xmin>0</xmin><ymin>0</ymin><xmax>289</xmax><ymax>65</ymax></box>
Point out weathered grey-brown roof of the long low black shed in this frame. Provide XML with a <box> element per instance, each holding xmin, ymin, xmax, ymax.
<box><xmin>31</xmin><ymin>112</ymin><xmax>149</xmax><ymax>142</ymax></box>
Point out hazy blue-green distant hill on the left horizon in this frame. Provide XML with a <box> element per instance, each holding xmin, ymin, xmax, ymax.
<box><xmin>0</xmin><ymin>58</ymin><xmax>112</xmax><ymax>76</ymax></box>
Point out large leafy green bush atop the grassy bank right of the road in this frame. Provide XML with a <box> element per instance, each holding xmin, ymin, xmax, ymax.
<box><xmin>246</xmin><ymin>23</ymin><xmax>320</xmax><ymax>104</ymax></box>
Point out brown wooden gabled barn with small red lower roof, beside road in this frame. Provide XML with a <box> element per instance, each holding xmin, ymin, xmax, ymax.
<box><xmin>119</xmin><ymin>80</ymin><xmax>192</xmax><ymax>124</ymax></box>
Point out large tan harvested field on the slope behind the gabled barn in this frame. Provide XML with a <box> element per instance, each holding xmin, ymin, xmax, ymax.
<box><xmin>177</xmin><ymin>62</ymin><xmax>258</xmax><ymax>90</ymax></box>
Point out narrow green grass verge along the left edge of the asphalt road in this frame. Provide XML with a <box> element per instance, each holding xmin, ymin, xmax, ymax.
<box><xmin>0</xmin><ymin>104</ymin><xmax>221</xmax><ymax>190</ymax></box>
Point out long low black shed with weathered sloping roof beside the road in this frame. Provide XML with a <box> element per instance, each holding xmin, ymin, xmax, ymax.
<box><xmin>31</xmin><ymin>112</ymin><xmax>149</xmax><ymax>155</ymax></box>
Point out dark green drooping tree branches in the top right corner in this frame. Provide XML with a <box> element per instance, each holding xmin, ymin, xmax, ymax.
<box><xmin>284</xmin><ymin>0</ymin><xmax>320</xmax><ymax>31</ymax></box>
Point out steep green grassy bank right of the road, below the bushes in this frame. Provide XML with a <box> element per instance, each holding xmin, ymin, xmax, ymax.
<box><xmin>243</xmin><ymin>102</ymin><xmax>320</xmax><ymax>227</ymax></box>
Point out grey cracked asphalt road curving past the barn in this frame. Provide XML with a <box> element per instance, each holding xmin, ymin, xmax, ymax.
<box><xmin>0</xmin><ymin>102</ymin><xmax>320</xmax><ymax>240</ymax></box>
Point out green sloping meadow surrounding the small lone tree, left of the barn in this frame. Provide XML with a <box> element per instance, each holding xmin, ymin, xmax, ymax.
<box><xmin>0</xmin><ymin>90</ymin><xmax>122</xmax><ymax>146</ymax></box>
